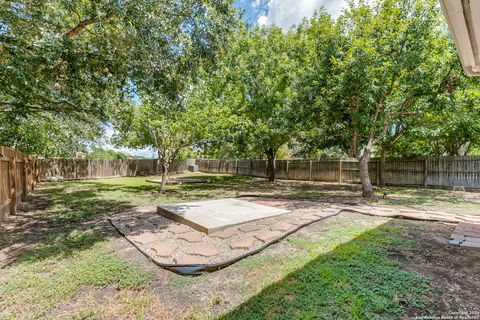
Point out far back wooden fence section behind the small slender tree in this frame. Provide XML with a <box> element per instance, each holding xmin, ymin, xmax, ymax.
<box><xmin>39</xmin><ymin>159</ymin><xmax>195</xmax><ymax>181</ymax></box>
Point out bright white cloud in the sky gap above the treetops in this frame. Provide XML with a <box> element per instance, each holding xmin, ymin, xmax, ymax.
<box><xmin>252</xmin><ymin>0</ymin><xmax>346</xmax><ymax>30</ymax></box>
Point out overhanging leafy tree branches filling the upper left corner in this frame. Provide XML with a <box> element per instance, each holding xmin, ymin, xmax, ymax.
<box><xmin>0</xmin><ymin>0</ymin><xmax>236</xmax><ymax>152</ymax></box>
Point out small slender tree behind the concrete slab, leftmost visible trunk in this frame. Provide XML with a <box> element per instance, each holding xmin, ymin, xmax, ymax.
<box><xmin>114</xmin><ymin>93</ymin><xmax>215</xmax><ymax>193</ymax></box>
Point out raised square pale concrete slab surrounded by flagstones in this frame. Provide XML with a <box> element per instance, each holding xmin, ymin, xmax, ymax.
<box><xmin>157</xmin><ymin>199</ymin><xmax>289</xmax><ymax>234</ymax></box>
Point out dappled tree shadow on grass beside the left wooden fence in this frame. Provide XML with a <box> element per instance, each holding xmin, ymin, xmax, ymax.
<box><xmin>0</xmin><ymin>183</ymin><xmax>137</xmax><ymax>266</ymax></box>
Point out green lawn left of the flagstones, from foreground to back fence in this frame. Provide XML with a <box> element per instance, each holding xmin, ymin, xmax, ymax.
<box><xmin>0</xmin><ymin>175</ymin><xmax>249</xmax><ymax>318</ymax></box>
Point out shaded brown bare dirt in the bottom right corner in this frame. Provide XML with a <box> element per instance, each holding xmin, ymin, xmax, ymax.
<box><xmin>393</xmin><ymin>220</ymin><xmax>480</xmax><ymax>319</ymax></box>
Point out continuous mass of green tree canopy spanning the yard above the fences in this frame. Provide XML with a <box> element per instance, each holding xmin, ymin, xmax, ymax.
<box><xmin>0</xmin><ymin>0</ymin><xmax>480</xmax><ymax>197</ymax></box>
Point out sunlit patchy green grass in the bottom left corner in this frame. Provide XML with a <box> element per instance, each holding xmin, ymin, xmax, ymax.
<box><xmin>0</xmin><ymin>243</ymin><xmax>151</xmax><ymax>318</ymax></box>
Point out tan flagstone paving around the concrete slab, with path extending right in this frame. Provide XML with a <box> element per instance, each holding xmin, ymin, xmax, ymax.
<box><xmin>110</xmin><ymin>198</ymin><xmax>480</xmax><ymax>274</ymax></box>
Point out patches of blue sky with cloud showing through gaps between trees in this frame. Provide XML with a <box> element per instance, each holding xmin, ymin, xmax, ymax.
<box><xmin>109</xmin><ymin>0</ymin><xmax>345</xmax><ymax>158</ymax></box>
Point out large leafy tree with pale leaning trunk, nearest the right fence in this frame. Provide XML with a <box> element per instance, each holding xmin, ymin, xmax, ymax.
<box><xmin>303</xmin><ymin>0</ymin><xmax>451</xmax><ymax>197</ymax></box>
